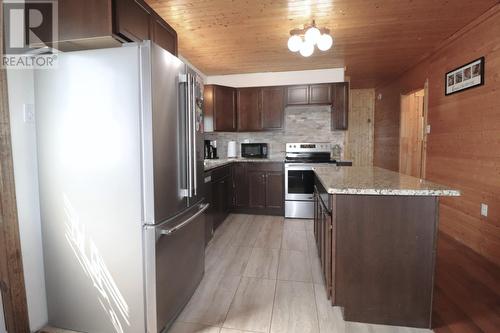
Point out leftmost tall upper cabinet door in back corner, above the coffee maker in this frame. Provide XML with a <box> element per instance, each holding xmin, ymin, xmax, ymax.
<box><xmin>213</xmin><ymin>86</ymin><xmax>237</xmax><ymax>132</ymax></box>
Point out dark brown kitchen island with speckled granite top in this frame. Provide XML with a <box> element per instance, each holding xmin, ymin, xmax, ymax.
<box><xmin>314</xmin><ymin>166</ymin><xmax>460</xmax><ymax>328</ymax></box>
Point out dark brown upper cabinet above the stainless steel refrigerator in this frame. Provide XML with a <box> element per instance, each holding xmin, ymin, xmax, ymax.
<box><xmin>45</xmin><ymin>0</ymin><xmax>177</xmax><ymax>55</ymax></box>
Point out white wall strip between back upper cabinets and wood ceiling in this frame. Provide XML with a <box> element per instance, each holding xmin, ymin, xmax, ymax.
<box><xmin>205</xmin><ymin>68</ymin><xmax>344</xmax><ymax>88</ymax></box>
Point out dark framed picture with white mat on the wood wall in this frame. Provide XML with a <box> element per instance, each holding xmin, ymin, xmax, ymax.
<box><xmin>444</xmin><ymin>57</ymin><xmax>484</xmax><ymax>96</ymax></box>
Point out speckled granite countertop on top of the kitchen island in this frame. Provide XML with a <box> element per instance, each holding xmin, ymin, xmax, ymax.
<box><xmin>313</xmin><ymin>166</ymin><xmax>460</xmax><ymax>196</ymax></box>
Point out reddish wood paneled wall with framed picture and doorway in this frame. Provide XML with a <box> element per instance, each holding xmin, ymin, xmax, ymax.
<box><xmin>374</xmin><ymin>4</ymin><xmax>500</xmax><ymax>264</ymax></box>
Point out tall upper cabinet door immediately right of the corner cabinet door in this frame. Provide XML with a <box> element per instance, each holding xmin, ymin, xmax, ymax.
<box><xmin>237</xmin><ymin>88</ymin><xmax>262</xmax><ymax>131</ymax></box>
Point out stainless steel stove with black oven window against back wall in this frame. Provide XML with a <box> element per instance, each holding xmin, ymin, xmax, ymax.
<box><xmin>285</xmin><ymin>142</ymin><xmax>336</xmax><ymax>219</ymax></box>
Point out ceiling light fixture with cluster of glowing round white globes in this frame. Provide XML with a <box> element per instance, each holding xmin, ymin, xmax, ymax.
<box><xmin>288</xmin><ymin>20</ymin><xmax>333</xmax><ymax>57</ymax></box>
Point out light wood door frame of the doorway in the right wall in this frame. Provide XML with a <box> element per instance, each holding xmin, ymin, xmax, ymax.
<box><xmin>398</xmin><ymin>79</ymin><xmax>429</xmax><ymax>179</ymax></box>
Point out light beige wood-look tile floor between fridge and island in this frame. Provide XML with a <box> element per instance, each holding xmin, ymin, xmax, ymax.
<box><xmin>42</xmin><ymin>214</ymin><xmax>431</xmax><ymax>333</ymax></box>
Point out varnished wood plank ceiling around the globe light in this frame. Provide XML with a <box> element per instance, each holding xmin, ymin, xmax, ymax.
<box><xmin>146</xmin><ymin>0</ymin><xmax>498</xmax><ymax>88</ymax></box>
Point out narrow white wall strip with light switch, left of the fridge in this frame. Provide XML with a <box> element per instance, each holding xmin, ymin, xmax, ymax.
<box><xmin>7</xmin><ymin>69</ymin><xmax>48</xmax><ymax>331</ymax></box>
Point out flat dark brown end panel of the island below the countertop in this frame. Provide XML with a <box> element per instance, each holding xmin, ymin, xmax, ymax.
<box><xmin>335</xmin><ymin>195</ymin><xmax>438</xmax><ymax>328</ymax></box>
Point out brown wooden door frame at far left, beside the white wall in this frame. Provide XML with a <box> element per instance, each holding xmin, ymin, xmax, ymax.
<box><xmin>0</xmin><ymin>6</ymin><xmax>30</xmax><ymax>333</ymax></box>
